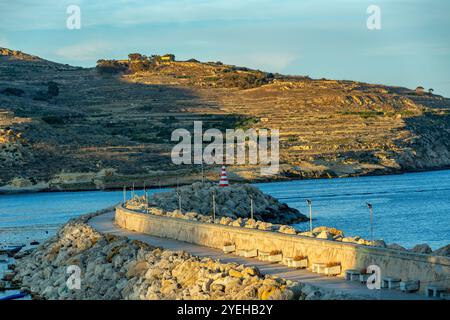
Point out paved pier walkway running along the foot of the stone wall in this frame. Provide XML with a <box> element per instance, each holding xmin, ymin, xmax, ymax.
<box><xmin>88</xmin><ymin>212</ymin><xmax>427</xmax><ymax>300</ymax></box>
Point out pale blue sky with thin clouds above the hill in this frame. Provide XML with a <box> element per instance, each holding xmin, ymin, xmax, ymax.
<box><xmin>0</xmin><ymin>0</ymin><xmax>450</xmax><ymax>97</ymax></box>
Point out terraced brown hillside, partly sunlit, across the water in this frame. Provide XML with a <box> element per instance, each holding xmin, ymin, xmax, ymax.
<box><xmin>0</xmin><ymin>48</ymin><xmax>450</xmax><ymax>191</ymax></box>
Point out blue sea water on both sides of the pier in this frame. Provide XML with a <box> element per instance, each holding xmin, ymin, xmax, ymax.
<box><xmin>0</xmin><ymin>170</ymin><xmax>450</xmax><ymax>249</ymax></box>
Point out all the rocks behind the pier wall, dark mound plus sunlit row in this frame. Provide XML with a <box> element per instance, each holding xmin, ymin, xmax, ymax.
<box><xmin>125</xmin><ymin>182</ymin><xmax>450</xmax><ymax>256</ymax></box>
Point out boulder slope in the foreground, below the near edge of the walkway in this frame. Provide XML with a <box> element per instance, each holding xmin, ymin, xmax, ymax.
<box><xmin>8</xmin><ymin>217</ymin><xmax>360</xmax><ymax>300</ymax></box>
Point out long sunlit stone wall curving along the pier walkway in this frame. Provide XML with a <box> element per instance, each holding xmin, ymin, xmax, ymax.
<box><xmin>115</xmin><ymin>206</ymin><xmax>450</xmax><ymax>289</ymax></box>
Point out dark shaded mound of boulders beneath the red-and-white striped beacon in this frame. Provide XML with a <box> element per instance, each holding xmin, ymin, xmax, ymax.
<box><xmin>149</xmin><ymin>182</ymin><xmax>308</xmax><ymax>224</ymax></box>
